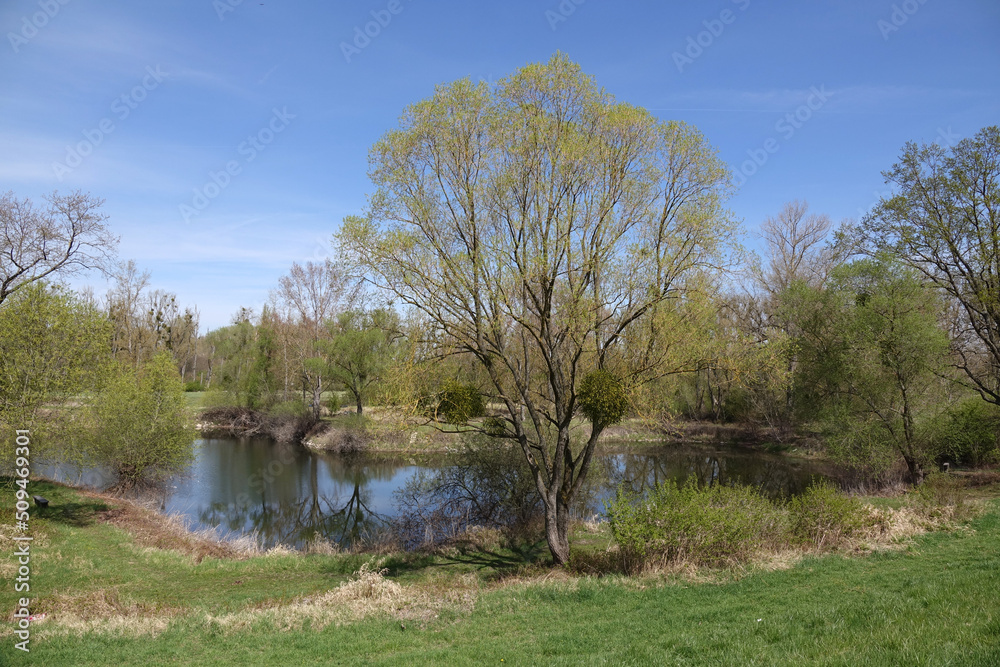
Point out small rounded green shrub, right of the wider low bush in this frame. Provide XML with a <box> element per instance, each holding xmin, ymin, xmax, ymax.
<box><xmin>788</xmin><ymin>481</ymin><xmax>871</xmax><ymax>549</ymax></box>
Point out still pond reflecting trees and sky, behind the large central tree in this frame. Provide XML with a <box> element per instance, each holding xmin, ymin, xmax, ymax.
<box><xmin>38</xmin><ymin>439</ymin><xmax>833</xmax><ymax>548</ymax></box>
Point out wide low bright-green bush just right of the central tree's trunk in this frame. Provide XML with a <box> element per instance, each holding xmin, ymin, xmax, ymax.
<box><xmin>607</xmin><ymin>480</ymin><xmax>787</xmax><ymax>565</ymax></box>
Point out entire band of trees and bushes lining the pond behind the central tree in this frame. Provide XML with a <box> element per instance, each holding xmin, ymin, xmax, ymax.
<box><xmin>0</xmin><ymin>128</ymin><xmax>1000</xmax><ymax>500</ymax></box>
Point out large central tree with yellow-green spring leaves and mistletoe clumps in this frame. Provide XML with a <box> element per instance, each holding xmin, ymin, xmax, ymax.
<box><xmin>340</xmin><ymin>54</ymin><xmax>735</xmax><ymax>564</ymax></box>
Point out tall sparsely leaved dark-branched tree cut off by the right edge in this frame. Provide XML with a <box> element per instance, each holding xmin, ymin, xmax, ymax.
<box><xmin>862</xmin><ymin>125</ymin><xmax>1000</xmax><ymax>405</ymax></box>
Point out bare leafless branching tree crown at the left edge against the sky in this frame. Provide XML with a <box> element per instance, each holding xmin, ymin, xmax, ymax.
<box><xmin>0</xmin><ymin>191</ymin><xmax>118</xmax><ymax>303</ymax></box>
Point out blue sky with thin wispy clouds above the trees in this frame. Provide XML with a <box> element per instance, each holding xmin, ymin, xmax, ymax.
<box><xmin>0</xmin><ymin>0</ymin><xmax>1000</xmax><ymax>331</ymax></box>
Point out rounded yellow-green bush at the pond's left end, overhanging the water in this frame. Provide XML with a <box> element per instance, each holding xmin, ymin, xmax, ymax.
<box><xmin>84</xmin><ymin>352</ymin><xmax>195</xmax><ymax>488</ymax></box>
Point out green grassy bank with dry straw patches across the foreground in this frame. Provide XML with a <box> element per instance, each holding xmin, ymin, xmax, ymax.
<box><xmin>0</xmin><ymin>482</ymin><xmax>1000</xmax><ymax>665</ymax></box>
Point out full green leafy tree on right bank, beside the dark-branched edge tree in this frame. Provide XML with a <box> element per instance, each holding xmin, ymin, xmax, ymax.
<box><xmin>783</xmin><ymin>257</ymin><xmax>948</xmax><ymax>482</ymax></box>
